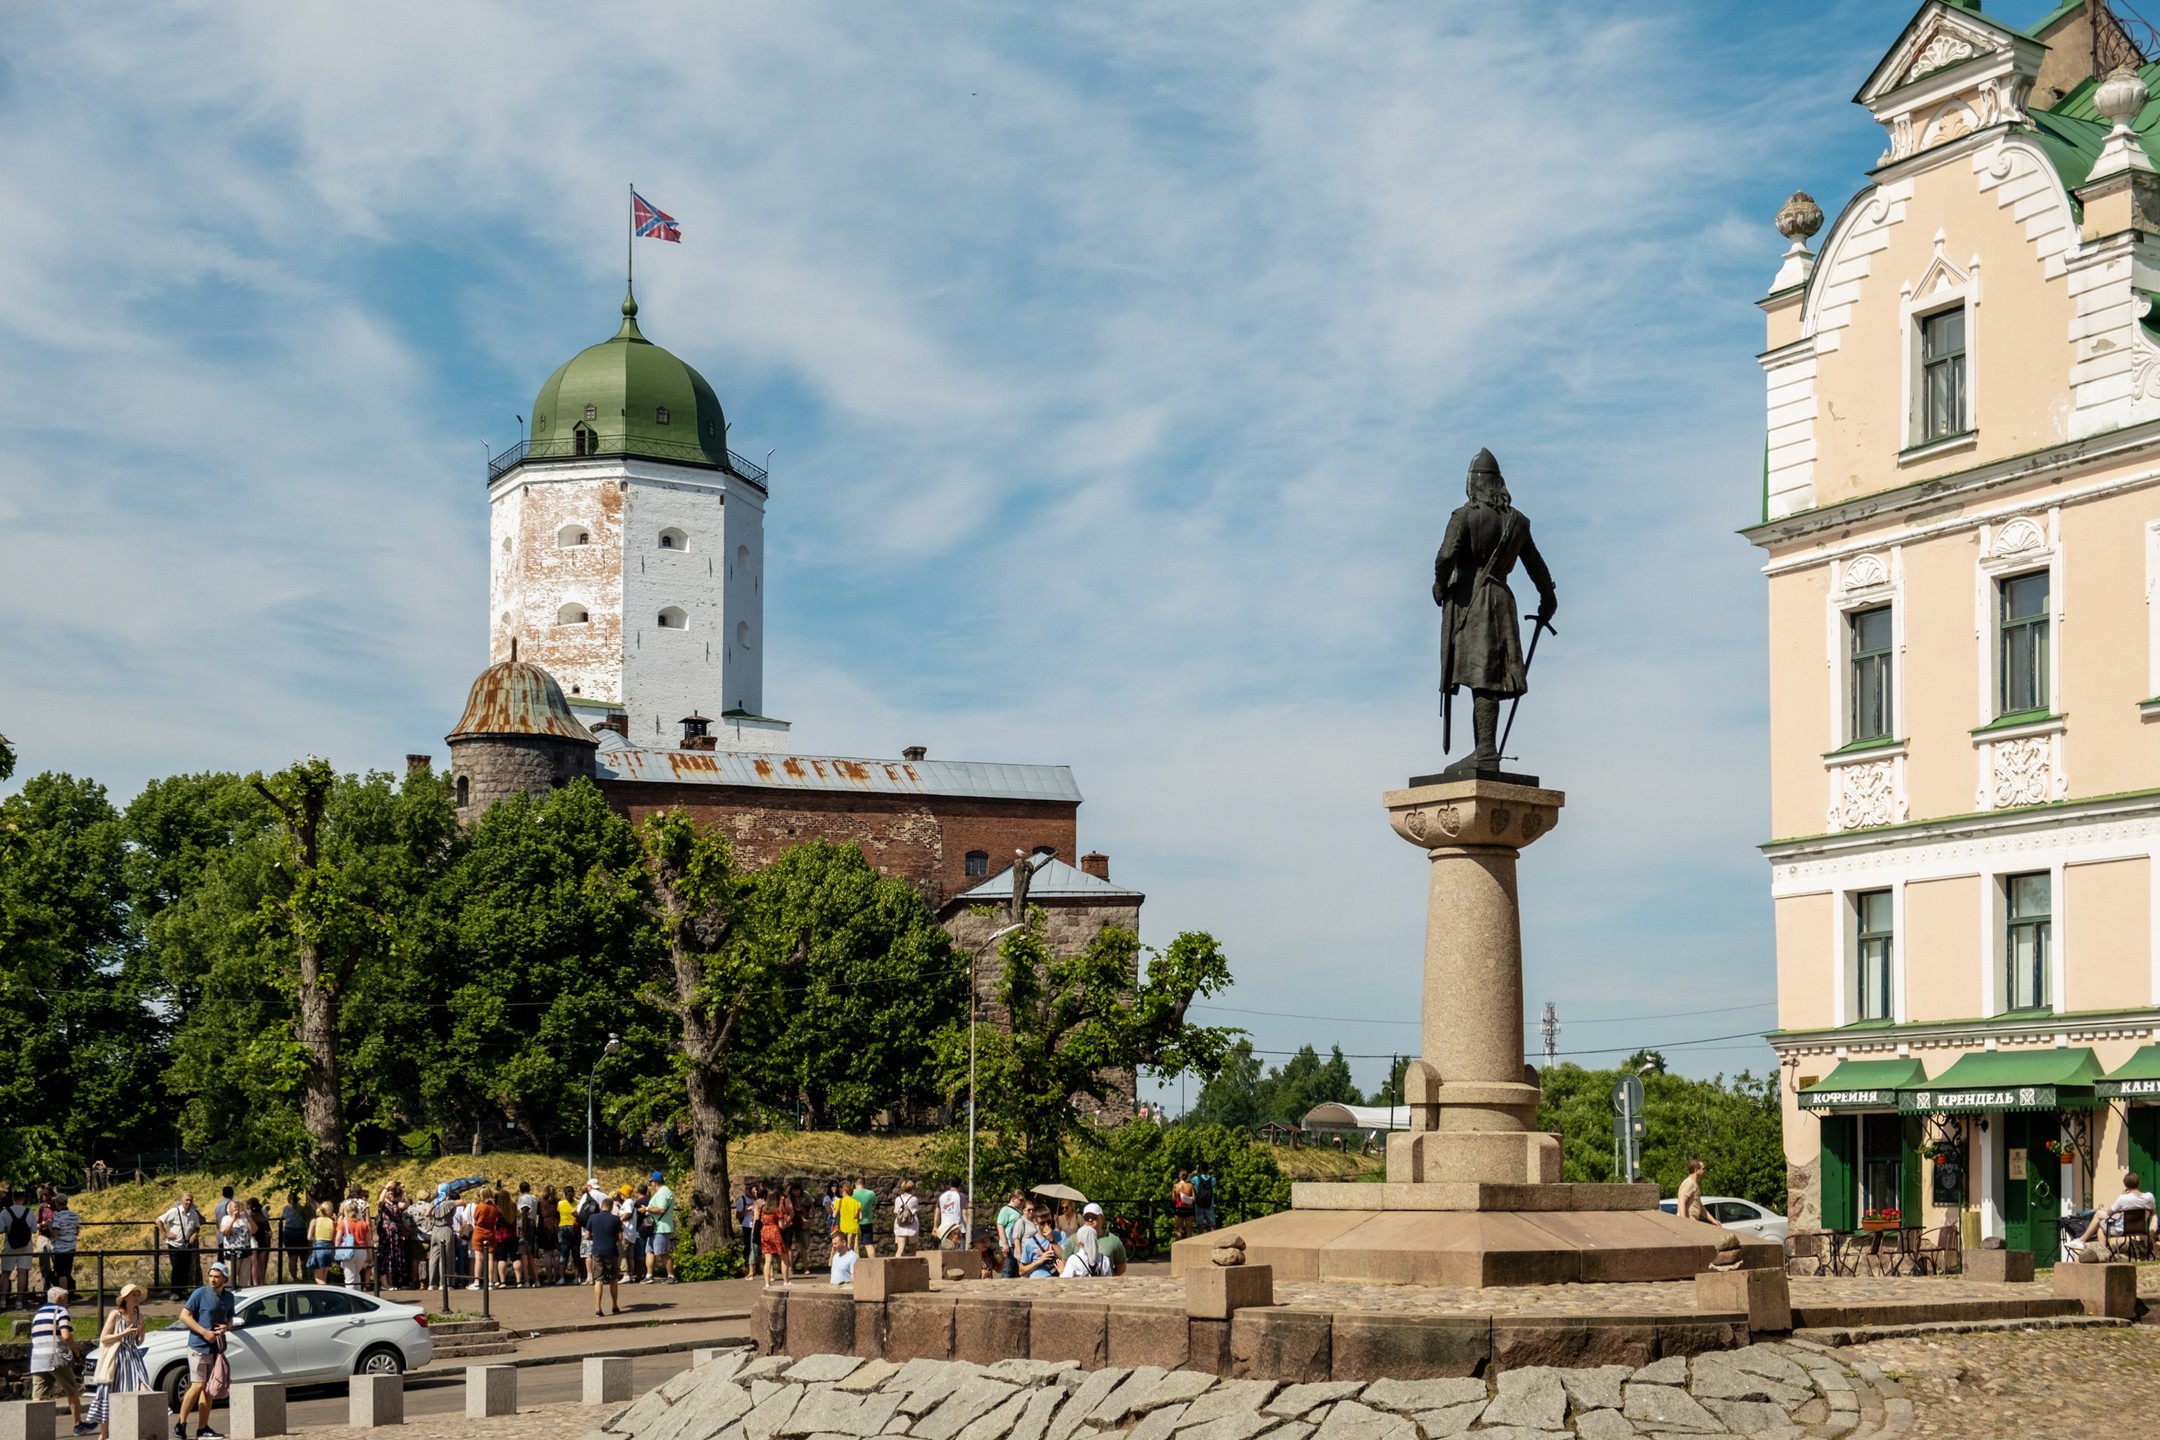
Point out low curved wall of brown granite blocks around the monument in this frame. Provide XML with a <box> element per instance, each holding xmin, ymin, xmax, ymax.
<box><xmin>750</xmin><ymin>1282</ymin><xmax>1747</xmax><ymax>1384</ymax></box>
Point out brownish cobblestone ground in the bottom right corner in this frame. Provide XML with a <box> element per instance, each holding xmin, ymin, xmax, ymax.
<box><xmin>1842</xmin><ymin>1326</ymin><xmax>2160</xmax><ymax>1440</ymax></box>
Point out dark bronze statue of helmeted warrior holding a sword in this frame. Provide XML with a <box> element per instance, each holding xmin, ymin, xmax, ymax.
<box><xmin>1432</xmin><ymin>449</ymin><xmax>1560</xmax><ymax>784</ymax></box>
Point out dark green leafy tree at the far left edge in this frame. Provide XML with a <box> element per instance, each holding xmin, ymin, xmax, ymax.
<box><xmin>0</xmin><ymin>775</ymin><xmax>160</xmax><ymax>1181</ymax></box>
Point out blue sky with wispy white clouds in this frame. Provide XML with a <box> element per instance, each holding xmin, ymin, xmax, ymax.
<box><xmin>0</xmin><ymin>0</ymin><xmax>2043</xmax><ymax>1084</ymax></box>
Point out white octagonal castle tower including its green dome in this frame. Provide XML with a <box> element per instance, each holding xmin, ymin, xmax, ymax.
<box><xmin>488</xmin><ymin>287</ymin><xmax>786</xmax><ymax>749</ymax></box>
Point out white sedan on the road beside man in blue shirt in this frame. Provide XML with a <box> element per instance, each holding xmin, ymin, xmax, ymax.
<box><xmin>143</xmin><ymin>1285</ymin><xmax>434</xmax><ymax>1410</ymax></box>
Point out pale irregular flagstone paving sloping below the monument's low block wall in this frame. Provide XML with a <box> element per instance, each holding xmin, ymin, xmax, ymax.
<box><xmin>585</xmin><ymin>1343</ymin><xmax>1912</xmax><ymax>1440</ymax></box>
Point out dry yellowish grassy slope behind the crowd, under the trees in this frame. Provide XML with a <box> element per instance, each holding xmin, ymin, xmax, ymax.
<box><xmin>73</xmin><ymin>1131</ymin><xmax>1385</xmax><ymax>1222</ymax></box>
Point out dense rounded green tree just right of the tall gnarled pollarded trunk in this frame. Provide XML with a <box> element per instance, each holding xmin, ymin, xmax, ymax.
<box><xmin>734</xmin><ymin>840</ymin><xmax>968</xmax><ymax>1129</ymax></box>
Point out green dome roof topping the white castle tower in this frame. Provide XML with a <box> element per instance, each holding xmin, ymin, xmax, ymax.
<box><xmin>525</xmin><ymin>296</ymin><xmax>728</xmax><ymax>468</ymax></box>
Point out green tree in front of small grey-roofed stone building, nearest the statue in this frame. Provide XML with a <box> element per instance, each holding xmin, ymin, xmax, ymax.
<box><xmin>937</xmin><ymin>909</ymin><xmax>1238</xmax><ymax>1183</ymax></box>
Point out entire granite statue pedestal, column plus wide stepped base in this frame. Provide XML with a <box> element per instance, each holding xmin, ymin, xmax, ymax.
<box><xmin>1166</xmin><ymin>777</ymin><xmax>1784</xmax><ymax>1286</ymax></box>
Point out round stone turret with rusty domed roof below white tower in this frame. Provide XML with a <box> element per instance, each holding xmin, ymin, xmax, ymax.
<box><xmin>449</xmin><ymin>658</ymin><xmax>598</xmax><ymax>820</ymax></box>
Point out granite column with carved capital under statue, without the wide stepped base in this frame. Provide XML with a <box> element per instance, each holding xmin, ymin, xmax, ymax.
<box><xmin>1385</xmin><ymin>779</ymin><xmax>1566</xmax><ymax>1185</ymax></box>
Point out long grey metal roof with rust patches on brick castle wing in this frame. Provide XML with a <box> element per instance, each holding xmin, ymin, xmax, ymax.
<box><xmin>596</xmin><ymin>743</ymin><xmax>1080</xmax><ymax>805</ymax></box>
